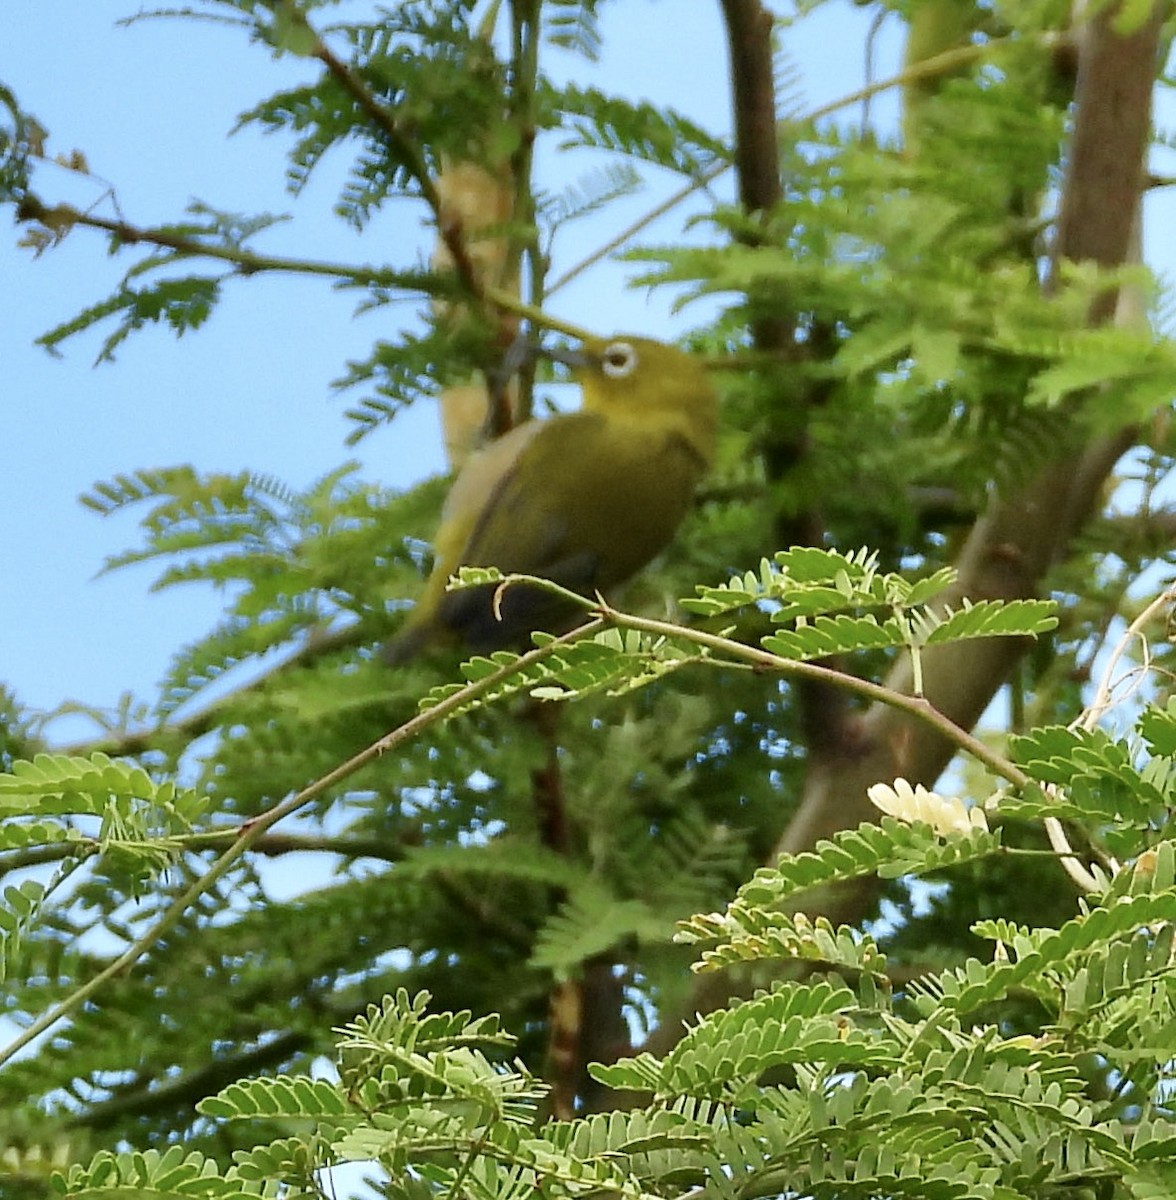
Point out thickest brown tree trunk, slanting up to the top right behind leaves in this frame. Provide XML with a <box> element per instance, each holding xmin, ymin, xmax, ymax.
<box><xmin>779</xmin><ymin>4</ymin><xmax>1168</xmax><ymax>920</ymax></box>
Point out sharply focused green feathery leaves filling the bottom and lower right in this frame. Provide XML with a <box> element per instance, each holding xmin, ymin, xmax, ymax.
<box><xmin>22</xmin><ymin>691</ymin><xmax>1176</xmax><ymax>1200</ymax></box>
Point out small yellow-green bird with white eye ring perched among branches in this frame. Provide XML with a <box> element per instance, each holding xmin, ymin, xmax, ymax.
<box><xmin>384</xmin><ymin>335</ymin><xmax>718</xmax><ymax>662</ymax></box>
